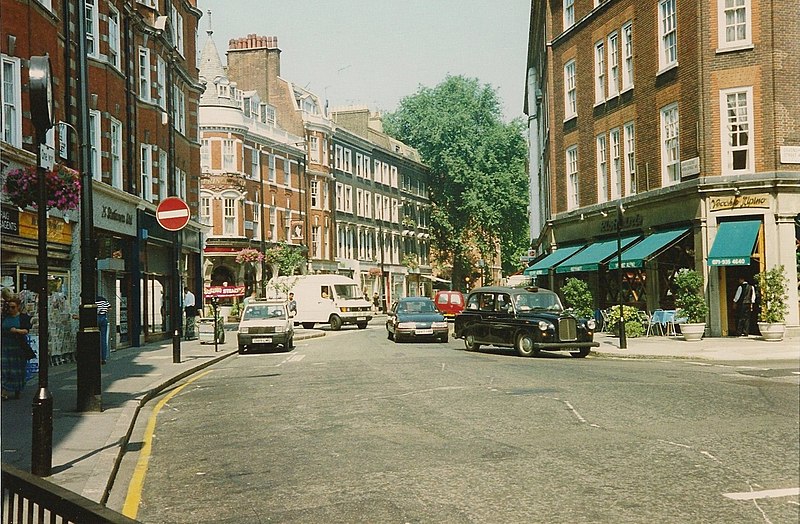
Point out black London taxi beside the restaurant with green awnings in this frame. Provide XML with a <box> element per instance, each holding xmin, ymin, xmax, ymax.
<box><xmin>454</xmin><ymin>286</ymin><xmax>600</xmax><ymax>357</ymax></box>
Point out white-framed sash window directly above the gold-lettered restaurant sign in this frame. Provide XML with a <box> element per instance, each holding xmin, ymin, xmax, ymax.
<box><xmin>720</xmin><ymin>87</ymin><xmax>754</xmax><ymax>174</ymax></box>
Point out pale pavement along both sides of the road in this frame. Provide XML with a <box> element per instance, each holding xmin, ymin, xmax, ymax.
<box><xmin>0</xmin><ymin>315</ymin><xmax>800</xmax><ymax>504</ymax></box>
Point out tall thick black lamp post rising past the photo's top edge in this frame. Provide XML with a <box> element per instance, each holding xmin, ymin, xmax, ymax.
<box><xmin>75</xmin><ymin>2</ymin><xmax>103</xmax><ymax>411</ymax></box>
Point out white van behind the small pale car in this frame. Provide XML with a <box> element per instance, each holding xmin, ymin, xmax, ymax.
<box><xmin>268</xmin><ymin>274</ymin><xmax>372</xmax><ymax>331</ymax></box>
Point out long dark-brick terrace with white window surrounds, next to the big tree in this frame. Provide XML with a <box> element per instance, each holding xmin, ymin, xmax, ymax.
<box><xmin>333</xmin><ymin>108</ymin><xmax>434</xmax><ymax>304</ymax></box>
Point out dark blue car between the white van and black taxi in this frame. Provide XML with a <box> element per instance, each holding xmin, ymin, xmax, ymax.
<box><xmin>386</xmin><ymin>297</ymin><xmax>450</xmax><ymax>342</ymax></box>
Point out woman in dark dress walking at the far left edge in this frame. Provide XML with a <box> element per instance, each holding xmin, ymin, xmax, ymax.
<box><xmin>0</xmin><ymin>295</ymin><xmax>32</xmax><ymax>400</ymax></box>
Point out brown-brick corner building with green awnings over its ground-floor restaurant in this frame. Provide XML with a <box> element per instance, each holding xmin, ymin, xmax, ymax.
<box><xmin>526</xmin><ymin>0</ymin><xmax>800</xmax><ymax>336</ymax></box>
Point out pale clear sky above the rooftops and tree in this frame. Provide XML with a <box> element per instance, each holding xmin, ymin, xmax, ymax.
<box><xmin>197</xmin><ymin>0</ymin><xmax>531</xmax><ymax>121</ymax></box>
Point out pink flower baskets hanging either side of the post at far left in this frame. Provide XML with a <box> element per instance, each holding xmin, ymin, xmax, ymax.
<box><xmin>3</xmin><ymin>166</ymin><xmax>81</xmax><ymax>211</ymax></box>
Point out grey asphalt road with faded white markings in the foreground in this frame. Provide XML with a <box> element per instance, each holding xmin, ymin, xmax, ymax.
<box><xmin>115</xmin><ymin>321</ymin><xmax>800</xmax><ymax>524</ymax></box>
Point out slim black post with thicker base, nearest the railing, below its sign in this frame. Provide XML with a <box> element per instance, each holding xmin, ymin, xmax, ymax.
<box><xmin>31</xmin><ymin>128</ymin><xmax>53</xmax><ymax>477</ymax></box>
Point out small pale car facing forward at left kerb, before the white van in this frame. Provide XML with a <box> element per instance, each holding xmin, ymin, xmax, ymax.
<box><xmin>237</xmin><ymin>300</ymin><xmax>294</xmax><ymax>353</ymax></box>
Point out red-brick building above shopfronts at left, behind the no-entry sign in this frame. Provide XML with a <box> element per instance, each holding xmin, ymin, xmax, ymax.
<box><xmin>0</xmin><ymin>0</ymin><xmax>206</xmax><ymax>360</ymax></box>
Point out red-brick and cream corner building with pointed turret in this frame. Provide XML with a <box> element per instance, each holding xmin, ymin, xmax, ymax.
<box><xmin>200</xmin><ymin>31</ymin><xmax>307</xmax><ymax>306</ymax></box>
